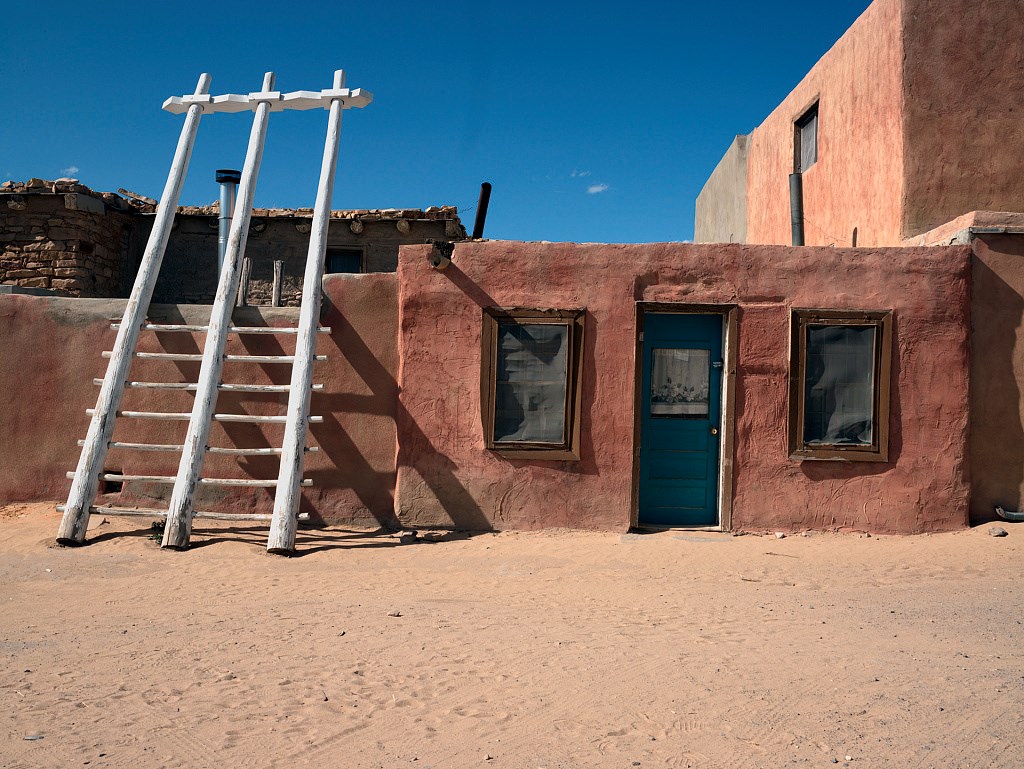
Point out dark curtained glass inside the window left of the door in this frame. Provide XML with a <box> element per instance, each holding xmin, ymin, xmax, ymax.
<box><xmin>495</xmin><ymin>323</ymin><xmax>569</xmax><ymax>443</ymax></box>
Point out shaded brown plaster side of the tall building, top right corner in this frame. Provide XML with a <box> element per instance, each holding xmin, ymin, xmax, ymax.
<box><xmin>894</xmin><ymin>0</ymin><xmax>1024</xmax><ymax>242</ymax></box>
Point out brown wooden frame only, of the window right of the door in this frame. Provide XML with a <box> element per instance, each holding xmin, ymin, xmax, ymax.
<box><xmin>790</xmin><ymin>309</ymin><xmax>893</xmax><ymax>462</ymax></box>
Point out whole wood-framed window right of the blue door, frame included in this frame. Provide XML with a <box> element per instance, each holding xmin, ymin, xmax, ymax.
<box><xmin>790</xmin><ymin>310</ymin><xmax>892</xmax><ymax>461</ymax></box>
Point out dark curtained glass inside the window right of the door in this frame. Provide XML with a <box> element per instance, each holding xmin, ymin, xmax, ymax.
<box><xmin>804</xmin><ymin>325</ymin><xmax>876</xmax><ymax>445</ymax></box>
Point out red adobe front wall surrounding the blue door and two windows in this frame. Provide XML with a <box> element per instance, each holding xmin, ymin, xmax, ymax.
<box><xmin>396</xmin><ymin>242</ymin><xmax>969</xmax><ymax>532</ymax></box>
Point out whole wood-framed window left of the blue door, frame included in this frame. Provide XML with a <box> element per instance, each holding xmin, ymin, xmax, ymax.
<box><xmin>480</xmin><ymin>308</ymin><xmax>583</xmax><ymax>459</ymax></box>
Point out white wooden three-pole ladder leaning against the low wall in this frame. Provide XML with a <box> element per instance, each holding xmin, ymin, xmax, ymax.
<box><xmin>57</xmin><ymin>70</ymin><xmax>373</xmax><ymax>554</ymax></box>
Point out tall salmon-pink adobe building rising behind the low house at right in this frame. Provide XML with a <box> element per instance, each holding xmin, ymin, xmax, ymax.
<box><xmin>694</xmin><ymin>0</ymin><xmax>1024</xmax><ymax>519</ymax></box>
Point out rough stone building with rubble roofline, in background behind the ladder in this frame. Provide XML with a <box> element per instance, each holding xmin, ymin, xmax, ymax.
<box><xmin>0</xmin><ymin>179</ymin><xmax>466</xmax><ymax>306</ymax></box>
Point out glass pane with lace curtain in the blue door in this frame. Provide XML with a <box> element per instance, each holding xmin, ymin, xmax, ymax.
<box><xmin>650</xmin><ymin>347</ymin><xmax>711</xmax><ymax>419</ymax></box>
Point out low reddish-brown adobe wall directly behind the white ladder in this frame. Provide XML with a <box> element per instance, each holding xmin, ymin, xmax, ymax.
<box><xmin>0</xmin><ymin>273</ymin><xmax>398</xmax><ymax>523</ymax></box>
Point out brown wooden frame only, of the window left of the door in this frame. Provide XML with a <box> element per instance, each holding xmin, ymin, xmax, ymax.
<box><xmin>480</xmin><ymin>307</ymin><xmax>586</xmax><ymax>461</ymax></box>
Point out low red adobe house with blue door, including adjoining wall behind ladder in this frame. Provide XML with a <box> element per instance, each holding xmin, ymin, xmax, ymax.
<box><xmin>0</xmin><ymin>234</ymin><xmax>970</xmax><ymax>532</ymax></box>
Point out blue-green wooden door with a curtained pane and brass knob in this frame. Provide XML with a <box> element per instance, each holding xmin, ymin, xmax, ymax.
<box><xmin>639</xmin><ymin>312</ymin><xmax>722</xmax><ymax>526</ymax></box>
